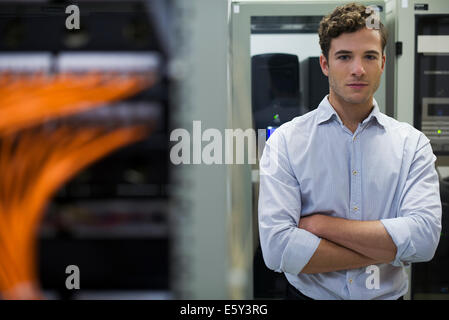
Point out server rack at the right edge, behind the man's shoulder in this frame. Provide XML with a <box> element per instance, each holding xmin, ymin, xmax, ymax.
<box><xmin>387</xmin><ymin>0</ymin><xmax>449</xmax><ymax>299</ymax></box>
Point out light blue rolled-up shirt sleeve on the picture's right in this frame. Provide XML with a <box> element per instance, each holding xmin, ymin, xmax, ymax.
<box><xmin>381</xmin><ymin>136</ymin><xmax>441</xmax><ymax>266</ymax></box>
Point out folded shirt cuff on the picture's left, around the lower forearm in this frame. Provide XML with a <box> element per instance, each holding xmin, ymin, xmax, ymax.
<box><xmin>281</xmin><ymin>228</ymin><xmax>321</xmax><ymax>275</ymax></box>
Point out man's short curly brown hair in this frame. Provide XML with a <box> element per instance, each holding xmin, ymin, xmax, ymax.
<box><xmin>318</xmin><ymin>3</ymin><xmax>388</xmax><ymax>59</ymax></box>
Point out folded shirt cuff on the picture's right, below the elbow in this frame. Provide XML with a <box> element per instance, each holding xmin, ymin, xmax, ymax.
<box><xmin>380</xmin><ymin>217</ymin><xmax>416</xmax><ymax>267</ymax></box>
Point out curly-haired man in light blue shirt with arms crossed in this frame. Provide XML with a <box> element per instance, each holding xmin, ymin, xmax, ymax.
<box><xmin>259</xmin><ymin>4</ymin><xmax>441</xmax><ymax>299</ymax></box>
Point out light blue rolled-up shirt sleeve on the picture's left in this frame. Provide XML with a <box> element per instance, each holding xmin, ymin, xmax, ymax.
<box><xmin>258</xmin><ymin>129</ymin><xmax>320</xmax><ymax>274</ymax></box>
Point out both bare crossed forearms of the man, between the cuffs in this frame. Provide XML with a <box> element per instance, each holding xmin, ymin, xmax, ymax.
<box><xmin>299</xmin><ymin>214</ymin><xmax>397</xmax><ymax>273</ymax></box>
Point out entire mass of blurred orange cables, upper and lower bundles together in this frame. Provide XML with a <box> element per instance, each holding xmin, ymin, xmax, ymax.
<box><xmin>0</xmin><ymin>73</ymin><xmax>156</xmax><ymax>299</ymax></box>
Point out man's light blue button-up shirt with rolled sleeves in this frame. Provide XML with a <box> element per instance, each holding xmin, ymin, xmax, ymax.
<box><xmin>258</xmin><ymin>97</ymin><xmax>441</xmax><ymax>299</ymax></box>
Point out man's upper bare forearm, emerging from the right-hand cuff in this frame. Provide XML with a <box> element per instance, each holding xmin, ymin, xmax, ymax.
<box><xmin>299</xmin><ymin>214</ymin><xmax>396</xmax><ymax>263</ymax></box>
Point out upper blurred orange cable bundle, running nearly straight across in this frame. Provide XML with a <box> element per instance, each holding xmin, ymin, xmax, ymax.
<box><xmin>0</xmin><ymin>73</ymin><xmax>155</xmax><ymax>134</ymax></box>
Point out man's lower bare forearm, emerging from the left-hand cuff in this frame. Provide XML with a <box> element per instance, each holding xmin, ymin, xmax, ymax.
<box><xmin>301</xmin><ymin>239</ymin><xmax>381</xmax><ymax>274</ymax></box>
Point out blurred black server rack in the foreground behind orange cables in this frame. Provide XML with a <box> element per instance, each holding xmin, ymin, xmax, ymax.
<box><xmin>0</xmin><ymin>1</ymin><xmax>172</xmax><ymax>299</ymax></box>
